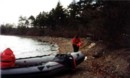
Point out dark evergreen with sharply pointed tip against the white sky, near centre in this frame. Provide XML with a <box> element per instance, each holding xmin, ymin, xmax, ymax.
<box><xmin>48</xmin><ymin>2</ymin><xmax>67</xmax><ymax>29</ymax></box>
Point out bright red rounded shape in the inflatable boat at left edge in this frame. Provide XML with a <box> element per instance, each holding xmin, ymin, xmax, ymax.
<box><xmin>0</xmin><ymin>48</ymin><xmax>15</xmax><ymax>68</ymax></box>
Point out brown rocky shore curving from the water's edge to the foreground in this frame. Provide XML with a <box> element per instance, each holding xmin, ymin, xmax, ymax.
<box><xmin>31</xmin><ymin>37</ymin><xmax>130</xmax><ymax>78</ymax></box>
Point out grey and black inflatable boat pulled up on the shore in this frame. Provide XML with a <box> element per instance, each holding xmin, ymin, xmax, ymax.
<box><xmin>1</xmin><ymin>52</ymin><xmax>85</xmax><ymax>78</ymax></box>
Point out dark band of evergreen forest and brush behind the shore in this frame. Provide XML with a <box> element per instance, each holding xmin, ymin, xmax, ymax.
<box><xmin>0</xmin><ymin>0</ymin><xmax>130</xmax><ymax>48</ymax></box>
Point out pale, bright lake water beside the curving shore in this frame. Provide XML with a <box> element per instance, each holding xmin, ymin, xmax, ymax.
<box><xmin>0</xmin><ymin>35</ymin><xmax>58</xmax><ymax>58</ymax></box>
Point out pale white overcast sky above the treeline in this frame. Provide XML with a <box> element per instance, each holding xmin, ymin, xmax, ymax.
<box><xmin>0</xmin><ymin>0</ymin><xmax>78</xmax><ymax>24</ymax></box>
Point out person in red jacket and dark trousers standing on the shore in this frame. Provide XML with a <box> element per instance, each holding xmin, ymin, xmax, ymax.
<box><xmin>72</xmin><ymin>35</ymin><xmax>81</xmax><ymax>52</ymax></box>
